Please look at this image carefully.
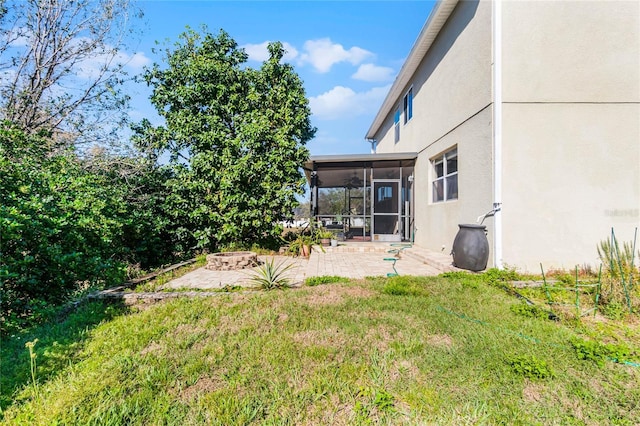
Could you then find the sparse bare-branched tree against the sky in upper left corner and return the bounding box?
[0,0,140,148]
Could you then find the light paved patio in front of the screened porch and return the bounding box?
[163,242,456,289]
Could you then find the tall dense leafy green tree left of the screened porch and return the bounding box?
[135,29,315,249]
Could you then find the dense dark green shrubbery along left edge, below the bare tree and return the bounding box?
[0,123,172,332]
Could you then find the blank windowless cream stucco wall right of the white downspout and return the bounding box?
[503,1,640,271]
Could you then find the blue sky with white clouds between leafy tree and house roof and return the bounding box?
[130,0,434,155]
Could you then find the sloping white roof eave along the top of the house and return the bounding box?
[365,0,458,140]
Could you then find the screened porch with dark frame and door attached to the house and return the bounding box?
[305,153,418,242]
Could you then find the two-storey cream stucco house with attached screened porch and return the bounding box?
[308,0,640,271]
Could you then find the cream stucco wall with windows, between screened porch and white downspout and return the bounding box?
[376,1,493,260]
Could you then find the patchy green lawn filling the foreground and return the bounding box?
[0,275,640,425]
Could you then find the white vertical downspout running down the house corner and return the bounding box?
[493,0,503,269]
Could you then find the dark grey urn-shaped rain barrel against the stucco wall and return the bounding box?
[451,224,489,271]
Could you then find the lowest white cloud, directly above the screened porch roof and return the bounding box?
[309,85,391,120]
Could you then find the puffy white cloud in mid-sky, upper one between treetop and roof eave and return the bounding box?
[300,38,373,73]
